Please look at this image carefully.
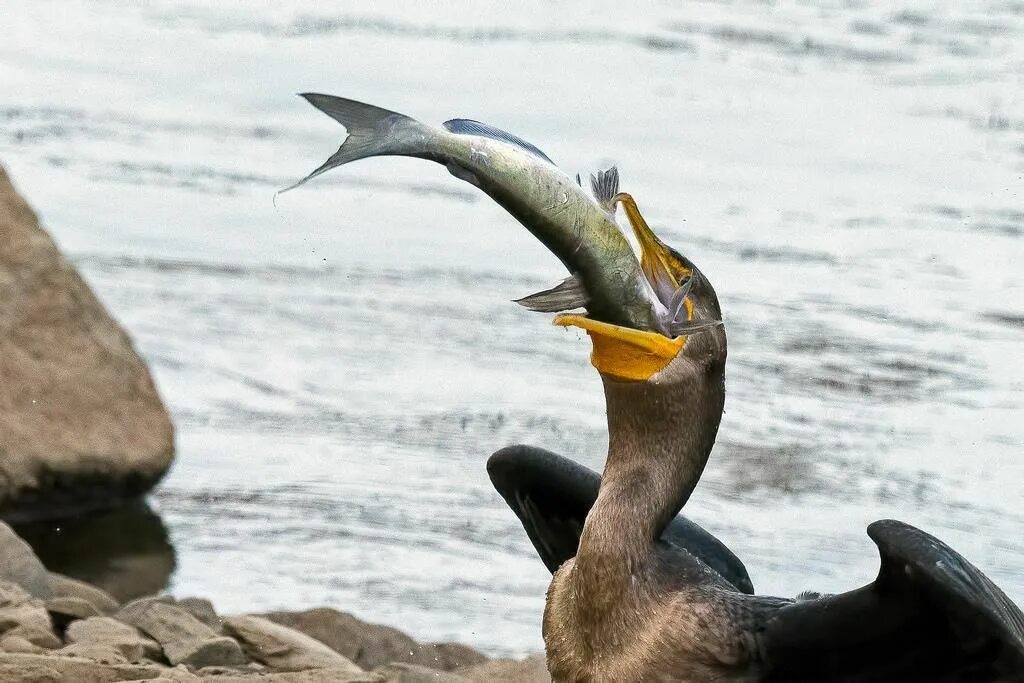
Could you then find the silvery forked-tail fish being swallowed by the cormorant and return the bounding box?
[282,92,720,338]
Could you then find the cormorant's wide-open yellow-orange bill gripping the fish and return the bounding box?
[554,193,721,381]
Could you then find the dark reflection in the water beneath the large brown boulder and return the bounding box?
[14,501,176,602]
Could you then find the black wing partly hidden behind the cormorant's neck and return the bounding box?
[487,445,754,594]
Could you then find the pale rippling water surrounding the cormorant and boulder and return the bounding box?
[0,0,1024,653]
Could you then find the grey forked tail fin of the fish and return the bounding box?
[281,92,432,193]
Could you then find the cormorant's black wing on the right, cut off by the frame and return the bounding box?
[750,520,1024,681]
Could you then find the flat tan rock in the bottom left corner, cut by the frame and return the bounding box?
[0,652,186,683]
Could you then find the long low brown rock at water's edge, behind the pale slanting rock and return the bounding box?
[263,607,486,671]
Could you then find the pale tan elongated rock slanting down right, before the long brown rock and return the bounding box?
[224,616,364,674]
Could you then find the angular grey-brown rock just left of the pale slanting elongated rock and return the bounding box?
[117,598,247,669]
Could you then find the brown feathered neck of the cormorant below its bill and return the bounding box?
[574,353,725,609]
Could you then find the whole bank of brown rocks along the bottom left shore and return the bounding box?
[0,522,549,683]
